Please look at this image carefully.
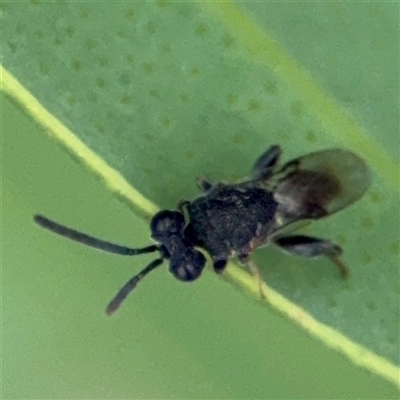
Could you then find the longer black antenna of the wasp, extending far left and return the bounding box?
[34,215,159,256]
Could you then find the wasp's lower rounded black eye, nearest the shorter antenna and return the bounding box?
[169,250,206,282]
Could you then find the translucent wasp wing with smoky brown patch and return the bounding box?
[274,149,371,224]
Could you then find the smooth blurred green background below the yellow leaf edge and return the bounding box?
[2,93,398,399]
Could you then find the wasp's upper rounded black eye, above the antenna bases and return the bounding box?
[150,210,185,241]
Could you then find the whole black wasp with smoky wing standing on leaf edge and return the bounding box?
[35,146,371,315]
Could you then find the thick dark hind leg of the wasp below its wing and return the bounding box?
[274,235,349,278]
